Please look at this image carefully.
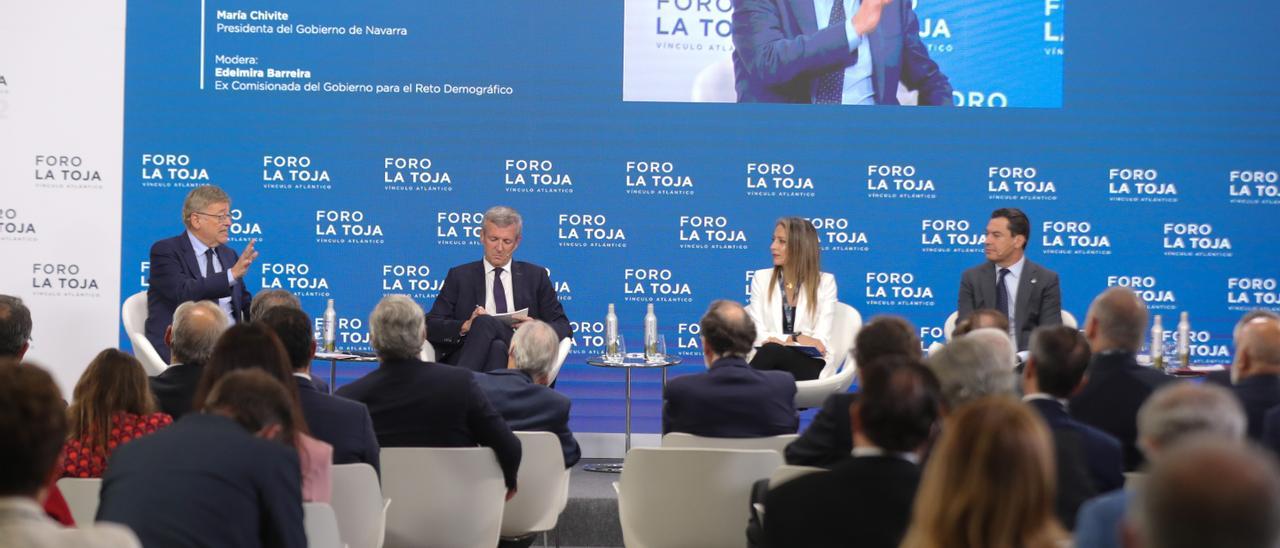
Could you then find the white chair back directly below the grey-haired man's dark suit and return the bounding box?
[381,447,507,548]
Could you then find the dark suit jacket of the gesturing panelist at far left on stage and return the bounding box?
[146,232,252,361]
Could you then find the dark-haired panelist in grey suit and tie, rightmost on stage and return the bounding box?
[956,207,1062,351]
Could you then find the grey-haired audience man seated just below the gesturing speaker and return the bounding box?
[147,301,227,420]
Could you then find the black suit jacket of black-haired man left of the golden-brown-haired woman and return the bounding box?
[764,456,920,548]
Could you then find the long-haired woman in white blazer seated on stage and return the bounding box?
[746,216,836,380]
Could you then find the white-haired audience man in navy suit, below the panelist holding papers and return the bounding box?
[475,320,582,467]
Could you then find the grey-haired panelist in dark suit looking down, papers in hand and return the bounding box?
[426,206,572,371]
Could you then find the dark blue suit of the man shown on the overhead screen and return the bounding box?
[733,0,952,106]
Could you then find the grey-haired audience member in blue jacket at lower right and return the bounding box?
[1075,383,1245,548]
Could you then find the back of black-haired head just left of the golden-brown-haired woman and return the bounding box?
[855,356,942,452]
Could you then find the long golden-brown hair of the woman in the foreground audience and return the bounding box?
[902,397,1070,548]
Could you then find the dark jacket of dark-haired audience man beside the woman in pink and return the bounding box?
[293,376,380,471]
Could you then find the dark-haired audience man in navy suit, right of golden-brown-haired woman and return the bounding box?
[1023,325,1124,529]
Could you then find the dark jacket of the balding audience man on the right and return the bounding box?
[1070,352,1171,470]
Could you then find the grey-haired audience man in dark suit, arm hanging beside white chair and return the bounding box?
[338,294,520,499]
